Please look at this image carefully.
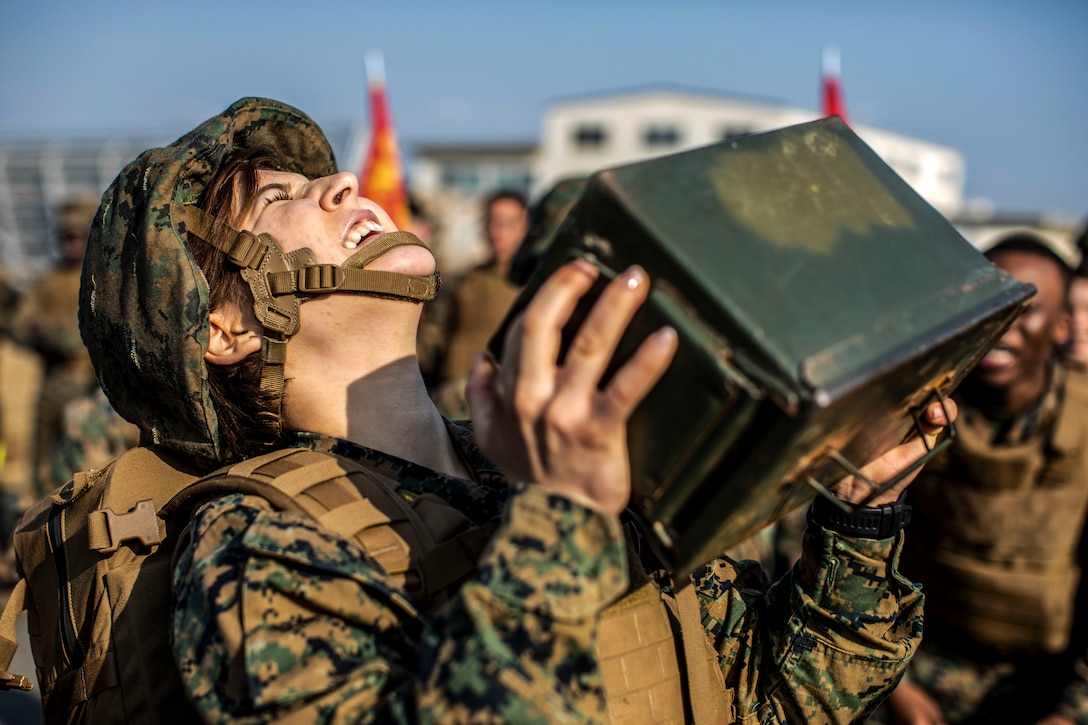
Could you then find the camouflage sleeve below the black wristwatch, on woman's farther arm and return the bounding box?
[693,522,923,724]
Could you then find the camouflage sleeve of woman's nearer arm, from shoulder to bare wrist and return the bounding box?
[171,487,627,723]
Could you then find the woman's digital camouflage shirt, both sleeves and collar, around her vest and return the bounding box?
[173,420,922,724]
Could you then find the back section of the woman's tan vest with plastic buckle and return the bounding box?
[0,447,199,723]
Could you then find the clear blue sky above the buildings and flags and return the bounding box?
[0,0,1088,220]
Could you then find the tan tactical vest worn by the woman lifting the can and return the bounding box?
[0,447,731,724]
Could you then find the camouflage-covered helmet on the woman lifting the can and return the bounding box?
[79,98,336,464]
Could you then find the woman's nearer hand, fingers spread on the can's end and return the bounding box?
[466,260,677,515]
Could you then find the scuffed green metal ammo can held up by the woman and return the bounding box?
[490,118,1035,575]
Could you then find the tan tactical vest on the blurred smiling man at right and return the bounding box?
[903,369,1088,653]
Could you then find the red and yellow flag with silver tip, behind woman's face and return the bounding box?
[359,51,411,230]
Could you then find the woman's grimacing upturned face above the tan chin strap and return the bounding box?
[236,171,435,277]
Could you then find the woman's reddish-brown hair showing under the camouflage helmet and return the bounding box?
[189,148,282,462]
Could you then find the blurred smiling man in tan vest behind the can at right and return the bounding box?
[888,233,1088,725]
